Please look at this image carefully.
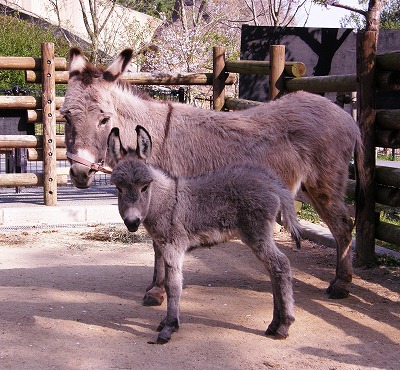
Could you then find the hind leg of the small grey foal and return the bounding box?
[246,227,294,339]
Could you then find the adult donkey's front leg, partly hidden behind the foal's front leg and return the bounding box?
[142,241,165,306]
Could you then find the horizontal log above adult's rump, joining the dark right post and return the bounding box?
[285,75,357,93]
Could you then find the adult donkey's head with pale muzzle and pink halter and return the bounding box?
[60,48,132,188]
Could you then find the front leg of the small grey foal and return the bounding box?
[157,246,184,344]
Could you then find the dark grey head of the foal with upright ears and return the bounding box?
[107,126,154,231]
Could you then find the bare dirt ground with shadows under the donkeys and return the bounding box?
[0,226,400,370]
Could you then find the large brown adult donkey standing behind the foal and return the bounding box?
[61,48,363,305]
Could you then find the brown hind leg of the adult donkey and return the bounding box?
[307,187,353,299]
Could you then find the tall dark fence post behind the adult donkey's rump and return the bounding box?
[355,31,378,266]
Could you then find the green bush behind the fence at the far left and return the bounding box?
[0,13,69,88]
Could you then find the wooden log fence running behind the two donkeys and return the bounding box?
[0,43,400,258]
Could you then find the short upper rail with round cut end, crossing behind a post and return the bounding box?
[225,60,306,77]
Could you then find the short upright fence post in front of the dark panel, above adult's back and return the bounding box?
[268,45,285,100]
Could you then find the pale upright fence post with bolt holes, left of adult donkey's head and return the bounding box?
[42,43,57,206]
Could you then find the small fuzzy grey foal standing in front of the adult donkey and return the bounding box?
[108,126,300,344]
